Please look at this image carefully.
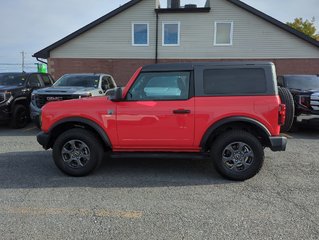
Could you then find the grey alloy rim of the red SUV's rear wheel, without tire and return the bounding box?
[222,142,254,172]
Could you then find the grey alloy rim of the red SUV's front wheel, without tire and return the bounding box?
[61,140,90,168]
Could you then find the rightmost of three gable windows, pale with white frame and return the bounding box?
[214,22,233,46]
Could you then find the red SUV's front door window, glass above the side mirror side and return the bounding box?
[127,72,190,101]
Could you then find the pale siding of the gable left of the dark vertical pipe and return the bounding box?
[50,0,156,59]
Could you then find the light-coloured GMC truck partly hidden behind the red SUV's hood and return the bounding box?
[30,73,116,125]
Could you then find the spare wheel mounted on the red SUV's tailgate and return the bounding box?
[278,87,295,132]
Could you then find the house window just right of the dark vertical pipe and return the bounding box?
[162,22,180,46]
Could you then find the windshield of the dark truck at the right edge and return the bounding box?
[285,75,319,90]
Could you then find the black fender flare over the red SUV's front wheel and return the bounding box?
[49,117,112,148]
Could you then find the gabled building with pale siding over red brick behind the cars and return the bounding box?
[34,0,319,85]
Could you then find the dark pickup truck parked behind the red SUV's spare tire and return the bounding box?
[278,75,319,127]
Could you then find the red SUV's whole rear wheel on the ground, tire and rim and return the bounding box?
[211,130,264,181]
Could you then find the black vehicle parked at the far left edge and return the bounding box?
[0,72,53,128]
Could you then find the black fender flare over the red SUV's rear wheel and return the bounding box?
[200,116,271,148]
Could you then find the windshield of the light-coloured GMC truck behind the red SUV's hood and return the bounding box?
[53,75,99,88]
